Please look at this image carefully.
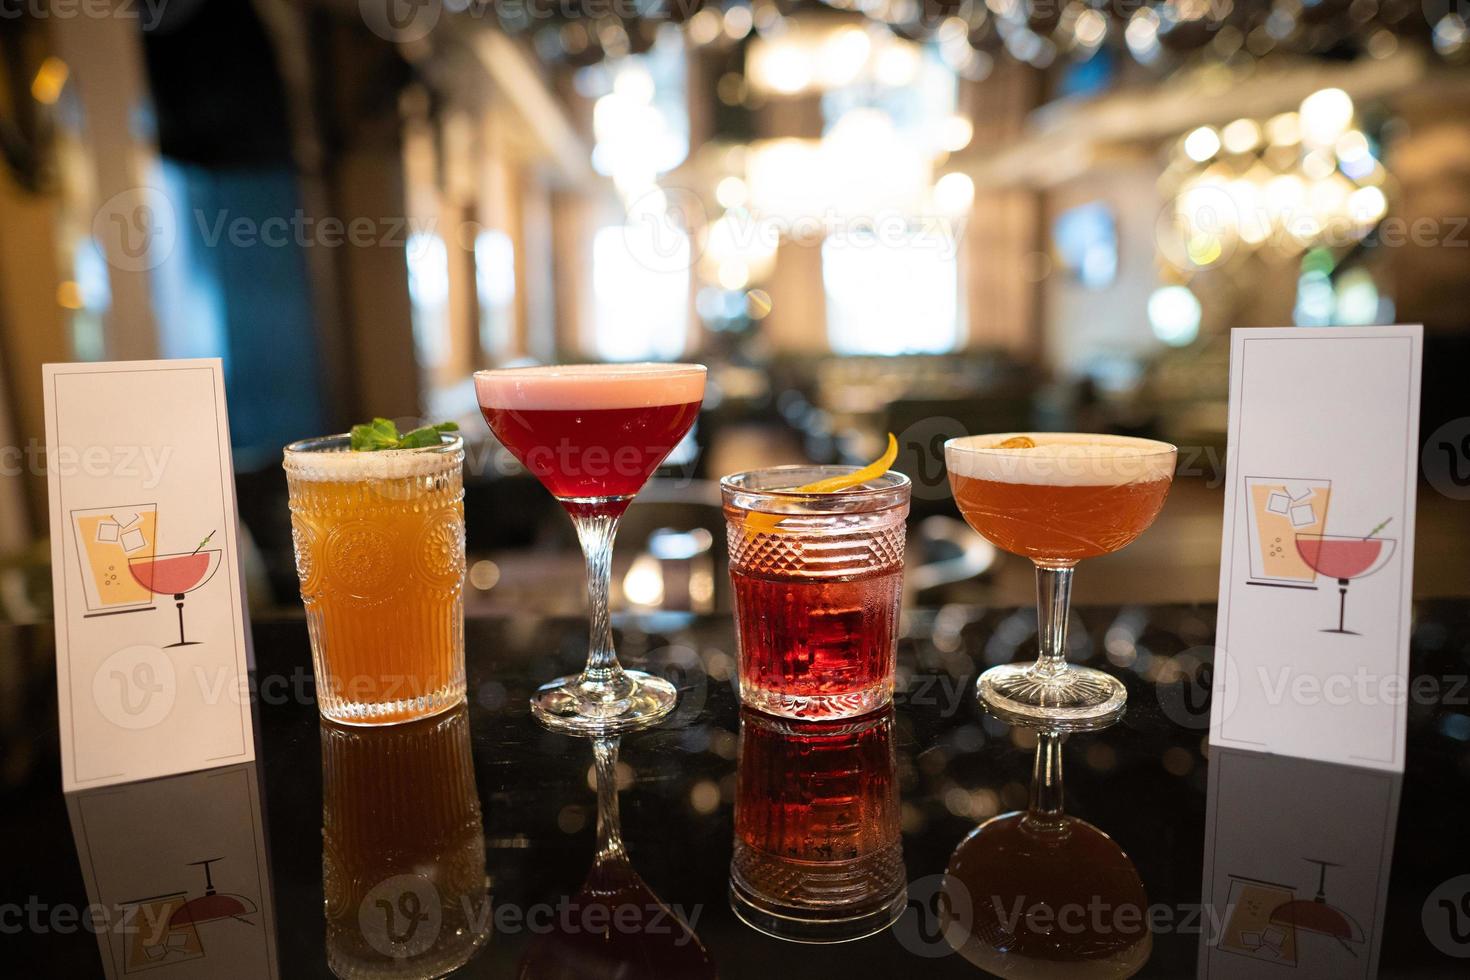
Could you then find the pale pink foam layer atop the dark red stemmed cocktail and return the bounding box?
[475,364,704,411]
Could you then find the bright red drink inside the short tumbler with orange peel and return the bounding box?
[731,564,904,717]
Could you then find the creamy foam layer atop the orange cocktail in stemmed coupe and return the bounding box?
[944,432,1177,486]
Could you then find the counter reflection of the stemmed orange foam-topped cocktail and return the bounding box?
[939,714,1154,980]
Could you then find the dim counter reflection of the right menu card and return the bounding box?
[1200,748,1401,980]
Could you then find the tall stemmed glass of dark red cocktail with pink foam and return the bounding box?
[475,364,704,733]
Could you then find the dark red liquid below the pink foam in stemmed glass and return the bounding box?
[481,401,700,497]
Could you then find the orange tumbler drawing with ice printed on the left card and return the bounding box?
[71,504,159,617]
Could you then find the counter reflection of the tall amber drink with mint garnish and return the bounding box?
[320,705,491,977]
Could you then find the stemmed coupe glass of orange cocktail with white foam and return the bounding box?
[944,432,1177,724]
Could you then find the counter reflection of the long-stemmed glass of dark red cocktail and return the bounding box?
[516,738,714,980]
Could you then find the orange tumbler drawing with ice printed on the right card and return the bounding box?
[1245,476,1332,589]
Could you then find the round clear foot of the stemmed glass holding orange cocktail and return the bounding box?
[976,664,1127,732]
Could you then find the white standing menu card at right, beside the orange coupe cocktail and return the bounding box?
[1210,326,1423,770]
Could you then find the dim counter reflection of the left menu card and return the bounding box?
[66,763,279,980]
